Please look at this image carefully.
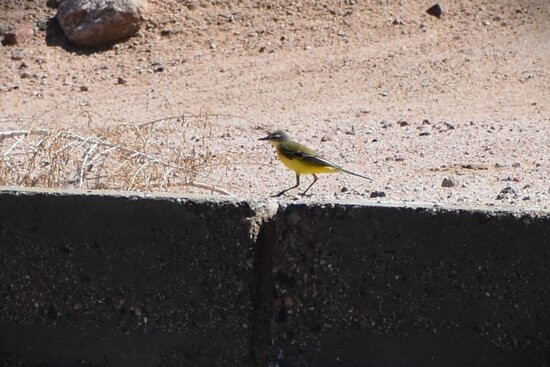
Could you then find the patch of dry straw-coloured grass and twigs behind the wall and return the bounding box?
[0,114,230,195]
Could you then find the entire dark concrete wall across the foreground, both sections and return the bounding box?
[0,191,550,366]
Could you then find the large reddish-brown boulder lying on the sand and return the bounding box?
[56,0,147,47]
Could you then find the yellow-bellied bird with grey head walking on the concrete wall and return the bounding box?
[260,130,372,196]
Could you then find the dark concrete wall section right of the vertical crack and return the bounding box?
[271,204,550,366]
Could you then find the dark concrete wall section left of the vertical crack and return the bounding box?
[0,192,260,366]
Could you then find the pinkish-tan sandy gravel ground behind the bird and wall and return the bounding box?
[0,0,550,210]
